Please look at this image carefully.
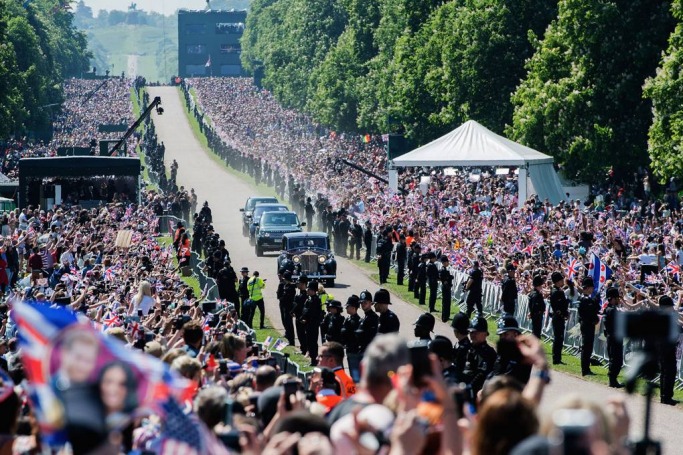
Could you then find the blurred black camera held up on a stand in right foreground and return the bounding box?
[615,310,680,344]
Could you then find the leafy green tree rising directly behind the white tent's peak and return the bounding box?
[382,0,555,143]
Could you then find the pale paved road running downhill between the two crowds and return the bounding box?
[149,87,683,453]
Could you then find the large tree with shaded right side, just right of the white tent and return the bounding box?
[507,0,673,181]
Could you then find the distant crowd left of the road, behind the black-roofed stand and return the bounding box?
[1,77,138,180]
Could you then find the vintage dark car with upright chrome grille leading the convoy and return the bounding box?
[277,232,337,288]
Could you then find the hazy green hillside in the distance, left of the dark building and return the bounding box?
[86,21,178,82]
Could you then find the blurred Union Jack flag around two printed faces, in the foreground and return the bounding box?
[12,301,196,447]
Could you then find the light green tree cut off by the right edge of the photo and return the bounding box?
[645,0,683,179]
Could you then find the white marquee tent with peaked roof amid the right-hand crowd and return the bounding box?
[389,120,564,205]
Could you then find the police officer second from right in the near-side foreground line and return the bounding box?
[463,316,496,397]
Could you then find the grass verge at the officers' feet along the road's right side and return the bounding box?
[349,259,683,407]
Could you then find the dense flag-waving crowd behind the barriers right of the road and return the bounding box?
[187,78,683,304]
